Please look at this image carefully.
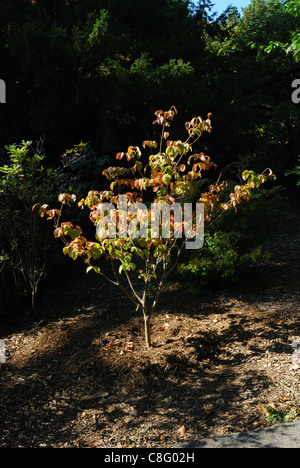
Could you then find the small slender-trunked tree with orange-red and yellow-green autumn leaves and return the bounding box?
[35,107,274,348]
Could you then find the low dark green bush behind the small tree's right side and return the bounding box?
[177,186,290,293]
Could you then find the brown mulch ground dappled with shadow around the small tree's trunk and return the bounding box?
[0,210,300,448]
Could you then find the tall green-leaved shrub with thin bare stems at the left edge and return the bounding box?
[0,141,59,313]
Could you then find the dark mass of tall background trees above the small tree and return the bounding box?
[0,0,300,318]
